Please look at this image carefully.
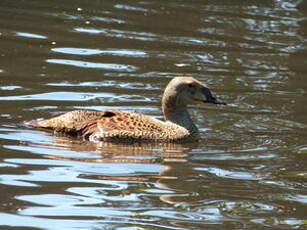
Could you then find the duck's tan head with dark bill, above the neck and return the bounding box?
[162,77,226,107]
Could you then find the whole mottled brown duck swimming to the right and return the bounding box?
[26,76,226,142]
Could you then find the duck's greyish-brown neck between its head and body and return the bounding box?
[162,101,198,133]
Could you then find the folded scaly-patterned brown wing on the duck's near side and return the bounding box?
[90,111,190,142]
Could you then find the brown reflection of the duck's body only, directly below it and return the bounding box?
[45,136,190,163]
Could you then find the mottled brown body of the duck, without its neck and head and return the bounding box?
[30,110,190,142]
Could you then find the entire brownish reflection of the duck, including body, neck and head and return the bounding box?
[38,137,197,204]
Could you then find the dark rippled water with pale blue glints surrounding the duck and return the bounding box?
[0,0,307,230]
